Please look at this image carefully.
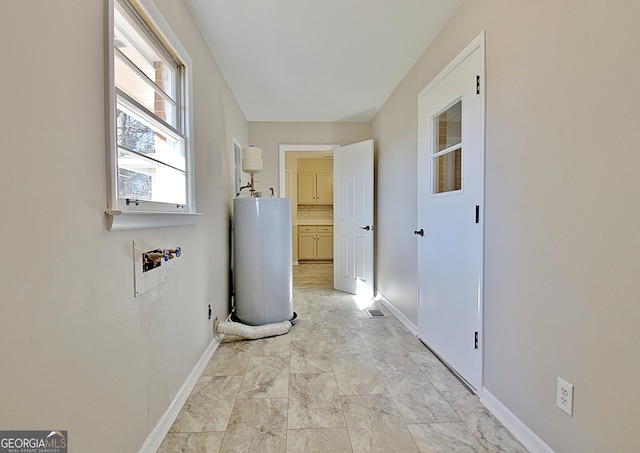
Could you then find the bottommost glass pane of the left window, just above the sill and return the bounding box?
[118,148,187,205]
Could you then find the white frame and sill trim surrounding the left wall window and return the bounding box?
[105,0,199,231]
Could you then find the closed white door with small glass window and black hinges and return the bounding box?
[416,36,484,390]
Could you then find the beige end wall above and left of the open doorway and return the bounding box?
[249,122,371,193]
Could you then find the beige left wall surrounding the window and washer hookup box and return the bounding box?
[0,0,248,452]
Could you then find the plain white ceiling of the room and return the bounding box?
[185,0,462,122]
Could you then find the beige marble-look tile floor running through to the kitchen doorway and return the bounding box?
[158,263,527,453]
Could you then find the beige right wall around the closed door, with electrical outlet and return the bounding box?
[371,0,640,453]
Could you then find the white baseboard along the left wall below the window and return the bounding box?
[139,337,220,453]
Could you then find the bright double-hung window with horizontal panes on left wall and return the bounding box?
[107,0,195,229]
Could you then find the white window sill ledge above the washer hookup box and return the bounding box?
[105,210,202,231]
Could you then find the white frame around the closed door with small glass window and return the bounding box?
[418,31,486,395]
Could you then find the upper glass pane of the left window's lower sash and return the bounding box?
[116,105,186,171]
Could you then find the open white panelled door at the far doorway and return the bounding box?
[333,140,374,297]
